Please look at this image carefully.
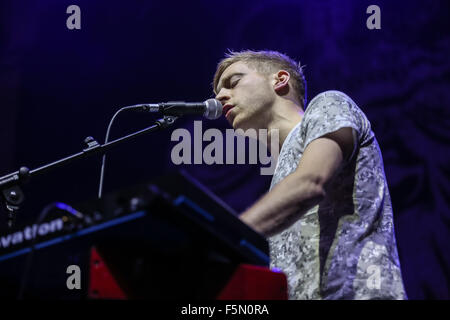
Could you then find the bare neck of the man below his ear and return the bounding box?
[267,100,304,151]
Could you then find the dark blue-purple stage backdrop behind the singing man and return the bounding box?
[0,0,450,299]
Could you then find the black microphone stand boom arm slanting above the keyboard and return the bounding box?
[0,116,177,228]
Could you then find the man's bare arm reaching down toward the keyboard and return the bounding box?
[240,128,356,236]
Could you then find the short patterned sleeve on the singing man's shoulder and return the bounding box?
[302,91,368,158]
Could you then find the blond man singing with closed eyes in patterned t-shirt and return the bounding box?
[214,51,406,299]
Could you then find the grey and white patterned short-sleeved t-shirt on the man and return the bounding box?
[268,91,406,299]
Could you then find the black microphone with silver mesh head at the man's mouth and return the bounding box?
[133,99,223,120]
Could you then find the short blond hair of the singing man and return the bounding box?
[213,50,306,109]
